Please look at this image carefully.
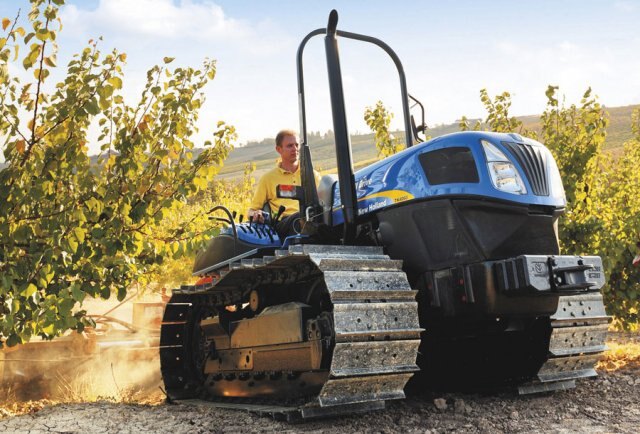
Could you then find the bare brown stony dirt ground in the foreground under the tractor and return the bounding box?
[0,334,640,434]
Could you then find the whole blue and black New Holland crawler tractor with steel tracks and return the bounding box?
[160,11,609,420]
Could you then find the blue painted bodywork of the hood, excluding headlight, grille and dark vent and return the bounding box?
[332,131,566,225]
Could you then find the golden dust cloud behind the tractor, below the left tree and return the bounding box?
[0,296,164,408]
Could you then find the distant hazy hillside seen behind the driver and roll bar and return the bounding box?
[218,105,640,179]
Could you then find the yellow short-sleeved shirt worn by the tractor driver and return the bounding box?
[249,162,320,216]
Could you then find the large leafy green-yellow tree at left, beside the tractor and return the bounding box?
[0,0,235,345]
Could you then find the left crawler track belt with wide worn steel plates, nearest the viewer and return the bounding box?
[160,245,422,420]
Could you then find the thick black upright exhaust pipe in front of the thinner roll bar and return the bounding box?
[324,9,357,244]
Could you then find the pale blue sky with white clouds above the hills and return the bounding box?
[0,0,640,151]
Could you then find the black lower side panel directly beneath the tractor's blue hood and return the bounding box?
[377,199,561,273]
